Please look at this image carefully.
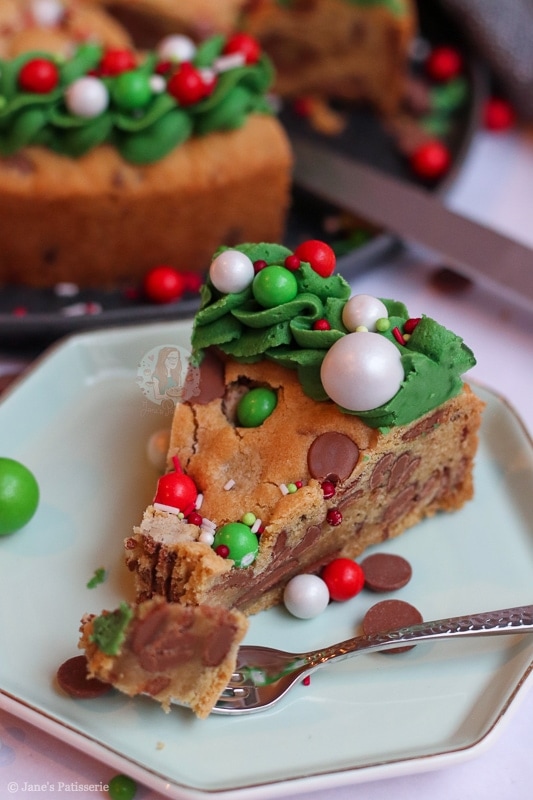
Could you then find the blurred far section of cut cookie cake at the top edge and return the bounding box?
[90,0,417,114]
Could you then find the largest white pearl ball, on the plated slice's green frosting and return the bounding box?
[320,332,405,411]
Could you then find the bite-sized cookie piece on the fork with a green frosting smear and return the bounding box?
[79,598,248,718]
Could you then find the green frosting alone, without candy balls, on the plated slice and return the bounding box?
[192,243,476,430]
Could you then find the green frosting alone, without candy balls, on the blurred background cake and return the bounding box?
[0,36,274,164]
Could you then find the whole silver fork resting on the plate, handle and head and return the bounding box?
[213,605,533,714]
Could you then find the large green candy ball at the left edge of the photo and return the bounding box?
[0,458,39,536]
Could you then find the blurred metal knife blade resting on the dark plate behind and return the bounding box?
[292,139,533,309]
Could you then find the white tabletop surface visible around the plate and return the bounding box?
[0,132,533,800]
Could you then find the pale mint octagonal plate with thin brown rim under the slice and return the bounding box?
[0,322,533,800]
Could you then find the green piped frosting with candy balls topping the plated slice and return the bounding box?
[192,242,476,430]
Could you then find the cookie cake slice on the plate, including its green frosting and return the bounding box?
[125,241,483,614]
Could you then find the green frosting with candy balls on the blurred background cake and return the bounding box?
[0,36,274,164]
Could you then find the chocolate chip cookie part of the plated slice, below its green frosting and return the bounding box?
[125,362,483,614]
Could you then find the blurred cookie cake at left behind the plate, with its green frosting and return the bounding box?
[0,16,291,288]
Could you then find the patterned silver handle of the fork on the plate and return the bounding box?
[305,605,533,668]
